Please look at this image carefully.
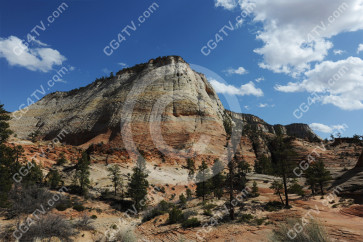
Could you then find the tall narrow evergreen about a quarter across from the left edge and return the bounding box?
[75,152,91,195]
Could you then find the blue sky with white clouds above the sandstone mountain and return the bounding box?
[0,0,363,137]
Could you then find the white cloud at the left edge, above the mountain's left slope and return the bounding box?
[0,36,66,72]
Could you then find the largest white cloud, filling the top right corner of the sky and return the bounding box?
[239,0,363,77]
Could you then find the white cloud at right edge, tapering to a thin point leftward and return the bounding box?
[275,57,363,110]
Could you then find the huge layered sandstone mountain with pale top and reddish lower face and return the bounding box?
[10,56,318,164]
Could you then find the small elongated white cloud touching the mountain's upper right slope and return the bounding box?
[210,79,263,97]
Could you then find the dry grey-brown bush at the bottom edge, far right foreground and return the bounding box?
[271,219,329,242]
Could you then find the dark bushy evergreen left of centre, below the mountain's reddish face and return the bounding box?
[128,156,149,210]
